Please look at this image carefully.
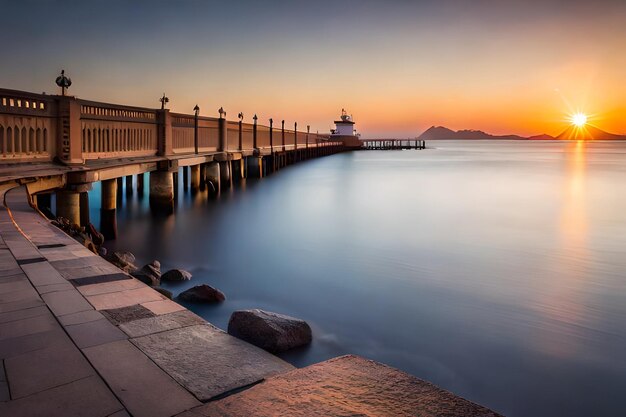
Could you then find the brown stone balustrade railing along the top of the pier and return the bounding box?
[0,89,329,165]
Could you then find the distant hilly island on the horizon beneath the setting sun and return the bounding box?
[418,125,626,140]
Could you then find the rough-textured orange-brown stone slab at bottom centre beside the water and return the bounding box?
[193,355,501,417]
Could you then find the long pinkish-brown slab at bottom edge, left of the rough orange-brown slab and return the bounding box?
[83,340,201,417]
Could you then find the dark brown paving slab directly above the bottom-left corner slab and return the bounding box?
[4,341,95,399]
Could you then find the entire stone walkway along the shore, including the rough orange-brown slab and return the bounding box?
[0,187,499,417]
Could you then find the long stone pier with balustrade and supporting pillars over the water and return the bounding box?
[0,89,350,239]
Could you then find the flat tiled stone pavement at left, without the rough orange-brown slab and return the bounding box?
[0,188,293,417]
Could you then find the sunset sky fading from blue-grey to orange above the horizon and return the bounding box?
[0,0,626,137]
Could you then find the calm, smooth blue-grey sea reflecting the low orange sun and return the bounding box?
[91,141,626,417]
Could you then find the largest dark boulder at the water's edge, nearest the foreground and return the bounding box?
[228,309,313,353]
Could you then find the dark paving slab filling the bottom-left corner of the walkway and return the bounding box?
[0,376,123,417]
